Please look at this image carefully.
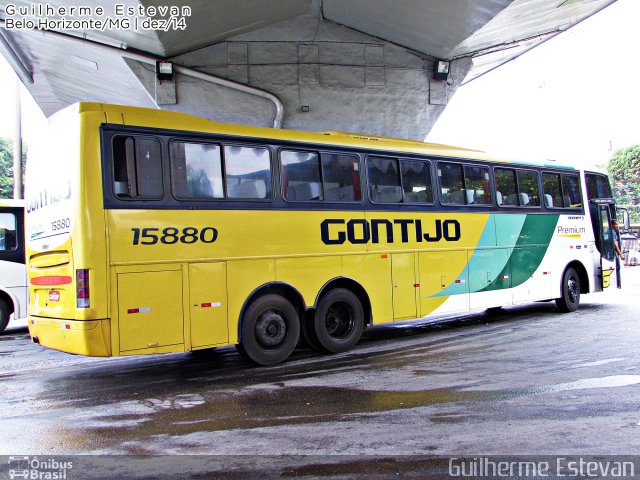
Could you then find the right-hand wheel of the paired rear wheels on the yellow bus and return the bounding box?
[314,288,364,353]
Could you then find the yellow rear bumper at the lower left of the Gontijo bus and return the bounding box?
[28,316,111,357]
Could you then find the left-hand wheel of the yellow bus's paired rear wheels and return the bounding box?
[238,295,300,365]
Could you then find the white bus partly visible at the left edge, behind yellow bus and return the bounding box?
[0,199,27,332]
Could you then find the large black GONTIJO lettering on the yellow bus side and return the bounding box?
[320,218,460,245]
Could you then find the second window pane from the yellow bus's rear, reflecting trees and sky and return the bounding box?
[170,142,224,199]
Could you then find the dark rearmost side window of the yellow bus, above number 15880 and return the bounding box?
[113,136,163,198]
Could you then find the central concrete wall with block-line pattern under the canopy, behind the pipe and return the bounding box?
[128,14,471,140]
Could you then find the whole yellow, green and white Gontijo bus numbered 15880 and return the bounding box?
[27,103,616,364]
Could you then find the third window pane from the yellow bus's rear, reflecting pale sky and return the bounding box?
[224,145,272,199]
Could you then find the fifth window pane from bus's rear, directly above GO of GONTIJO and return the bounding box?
[322,153,362,202]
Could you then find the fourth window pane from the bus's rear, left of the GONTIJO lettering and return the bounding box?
[280,150,324,201]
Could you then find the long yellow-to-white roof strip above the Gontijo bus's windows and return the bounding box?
[74,102,573,169]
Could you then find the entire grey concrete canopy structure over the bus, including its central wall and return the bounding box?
[0,0,615,139]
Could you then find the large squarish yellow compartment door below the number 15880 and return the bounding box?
[118,270,184,352]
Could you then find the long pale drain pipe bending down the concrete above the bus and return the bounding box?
[0,19,284,128]
